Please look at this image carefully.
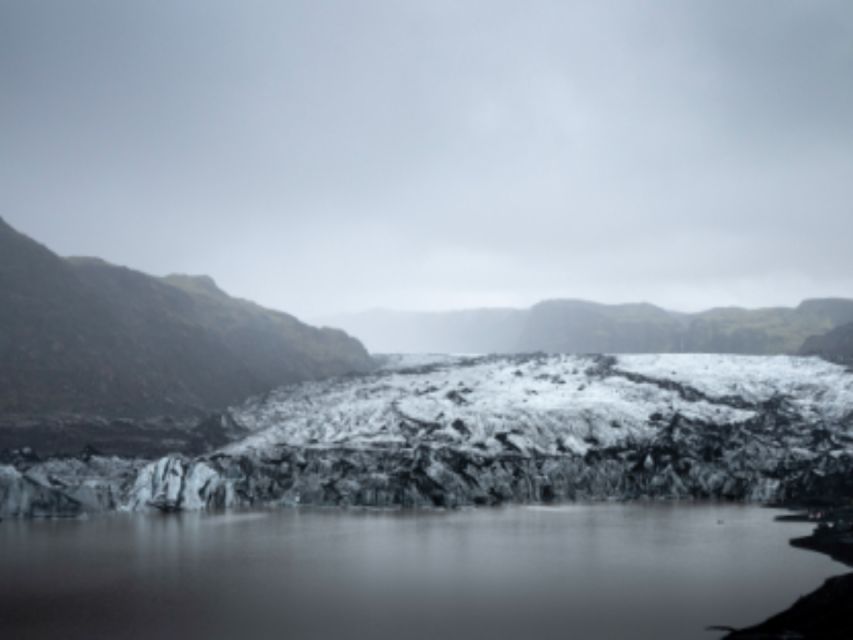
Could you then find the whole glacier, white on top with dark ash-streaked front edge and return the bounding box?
[0,354,853,517]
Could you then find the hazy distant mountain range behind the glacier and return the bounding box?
[323,298,853,356]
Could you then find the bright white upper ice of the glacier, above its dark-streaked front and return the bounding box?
[225,354,853,454]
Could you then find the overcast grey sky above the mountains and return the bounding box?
[0,0,853,317]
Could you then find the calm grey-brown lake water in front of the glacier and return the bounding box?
[0,503,845,640]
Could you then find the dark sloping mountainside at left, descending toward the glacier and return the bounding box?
[0,220,373,418]
